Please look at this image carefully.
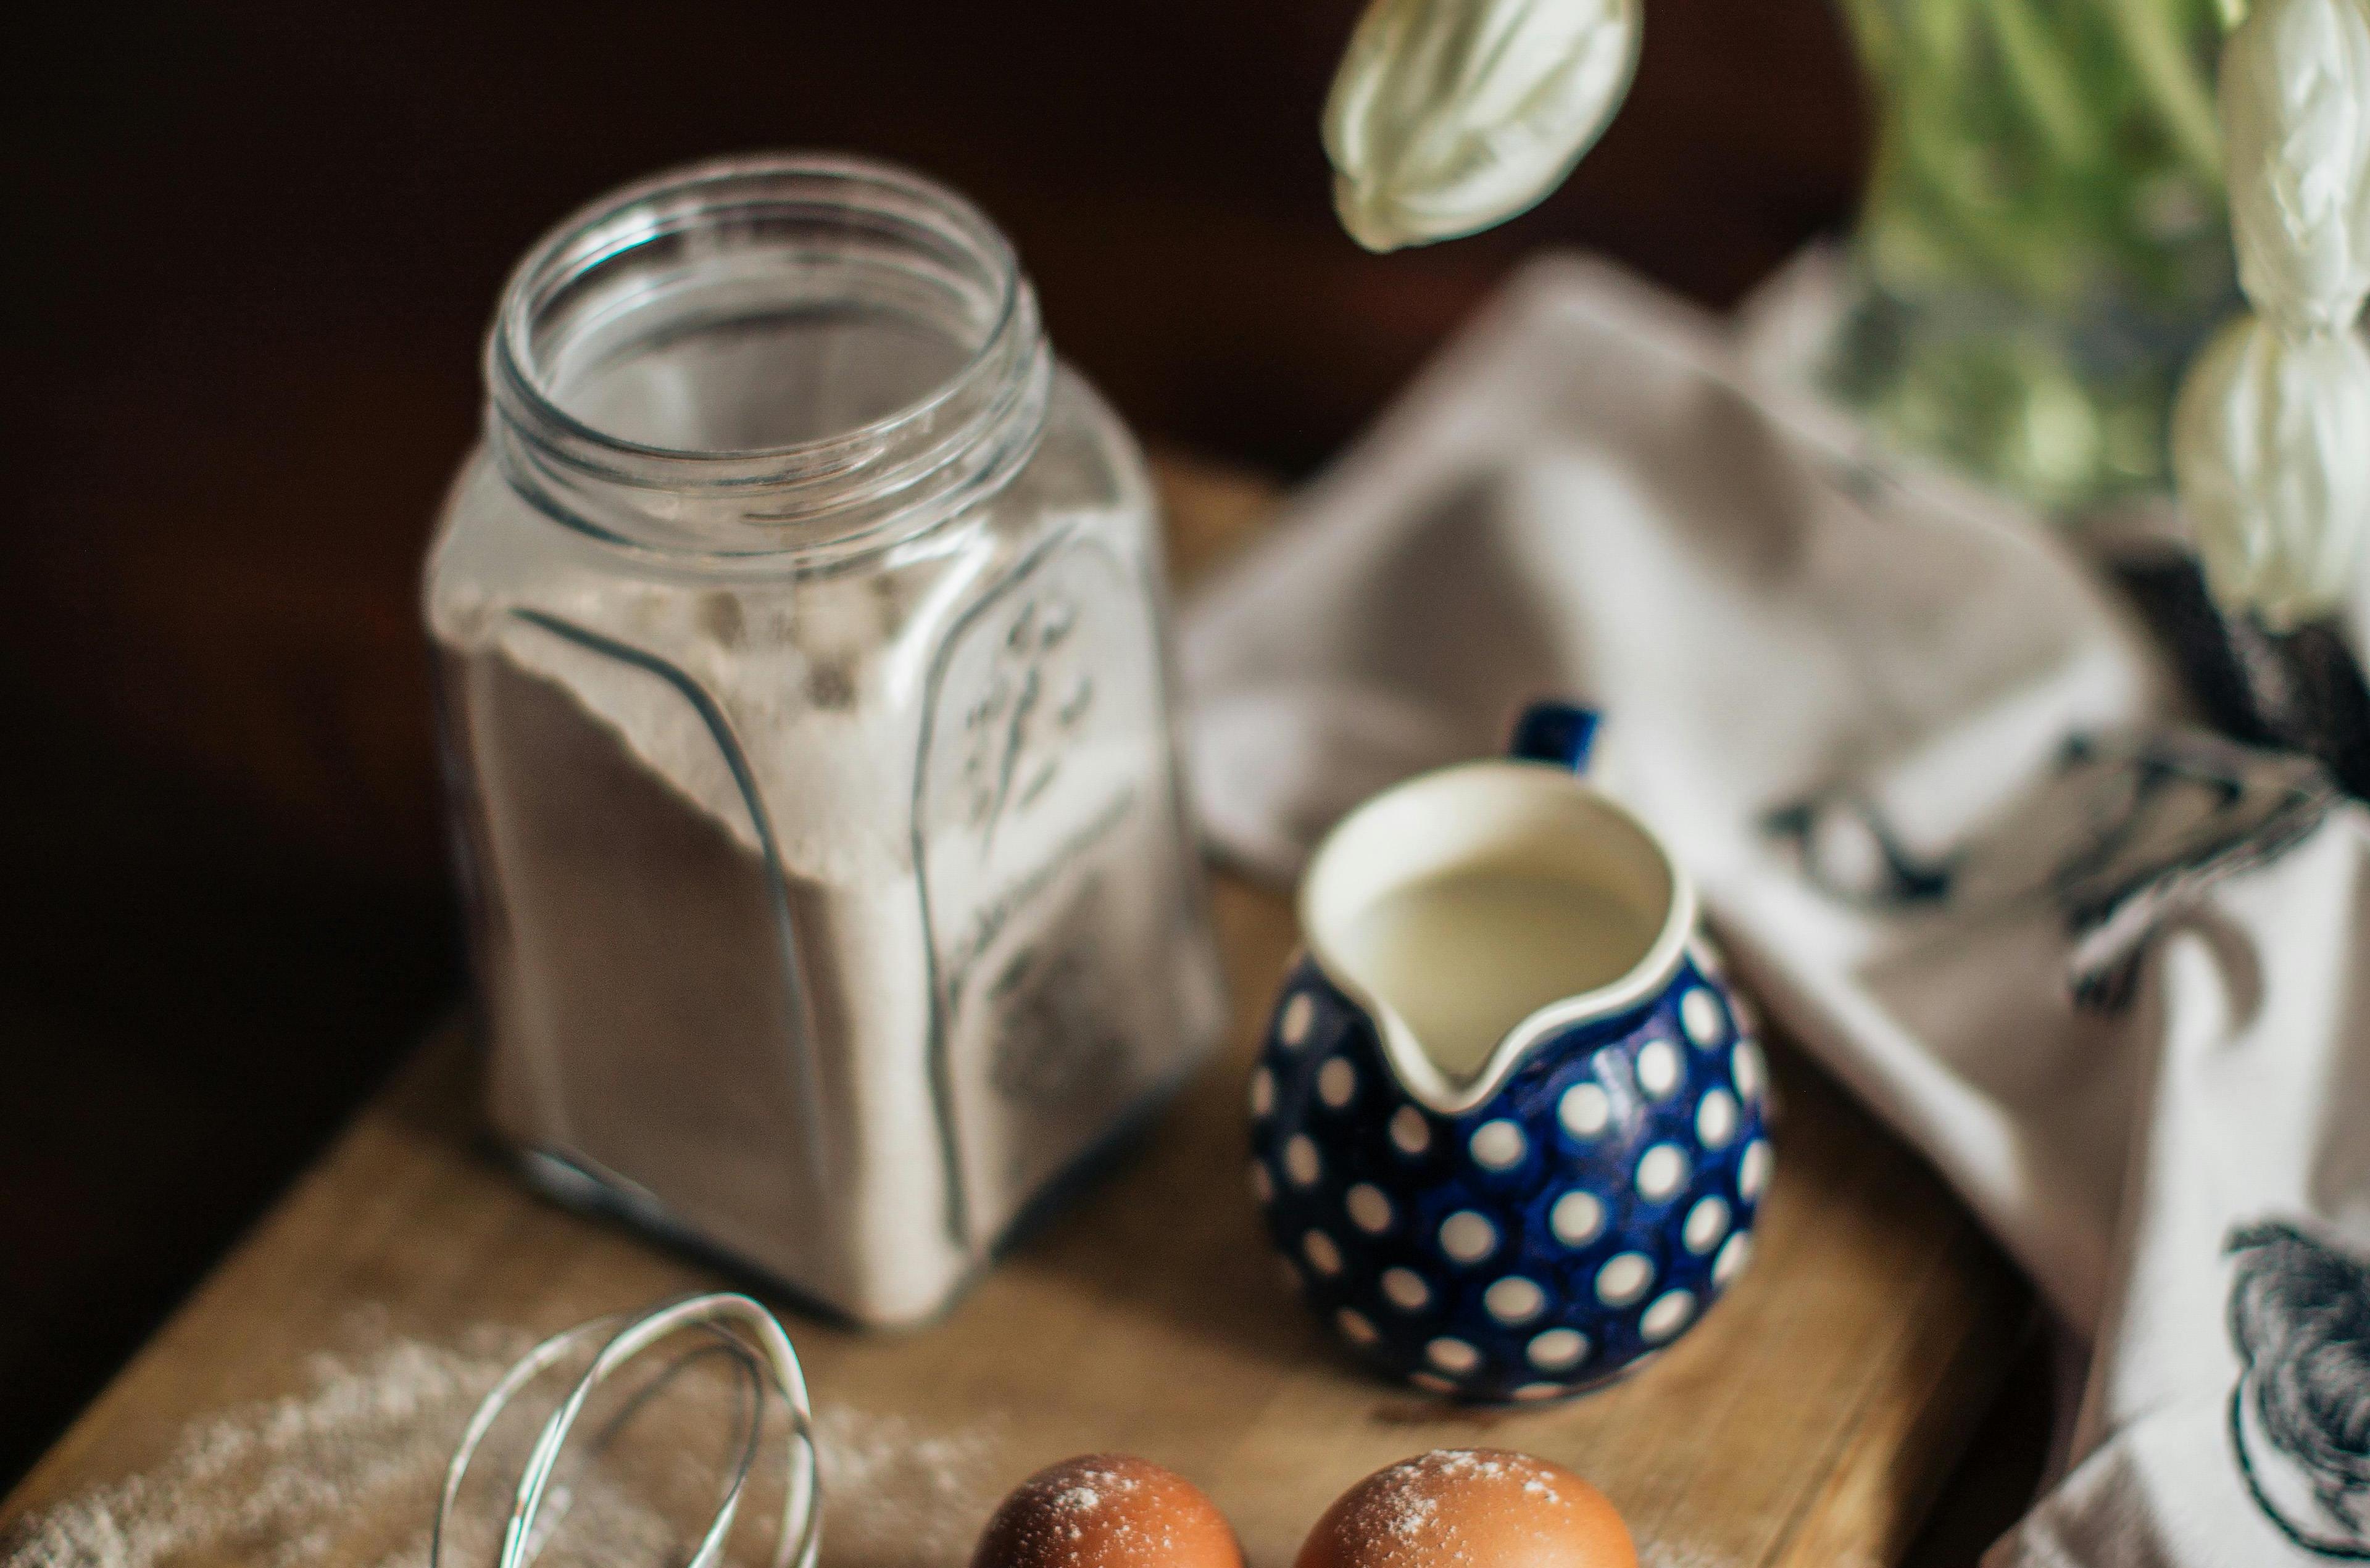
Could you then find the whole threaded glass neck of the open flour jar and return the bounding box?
[486,152,1052,559]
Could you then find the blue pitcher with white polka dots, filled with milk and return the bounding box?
[1252,703,1770,1400]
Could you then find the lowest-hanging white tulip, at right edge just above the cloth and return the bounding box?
[2173,315,2370,630]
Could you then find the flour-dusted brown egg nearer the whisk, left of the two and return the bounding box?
[971,1454,1242,1568]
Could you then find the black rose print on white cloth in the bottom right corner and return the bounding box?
[2223,1220,2370,1561]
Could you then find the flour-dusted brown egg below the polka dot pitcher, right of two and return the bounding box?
[1294,1447,1637,1568]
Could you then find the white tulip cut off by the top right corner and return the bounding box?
[2221,0,2370,327]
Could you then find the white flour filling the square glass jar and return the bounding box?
[431,469,1223,1322]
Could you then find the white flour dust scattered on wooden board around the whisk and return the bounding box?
[0,1326,996,1568]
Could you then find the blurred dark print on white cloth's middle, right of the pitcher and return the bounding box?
[1763,732,2337,1009]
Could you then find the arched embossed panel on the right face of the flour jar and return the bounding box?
[915,535,1192,1246]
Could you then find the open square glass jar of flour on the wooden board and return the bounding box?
[426,156,1223,1322]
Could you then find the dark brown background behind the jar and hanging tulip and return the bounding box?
[0,0,1865,1487]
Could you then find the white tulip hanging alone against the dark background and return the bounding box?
[1325,0,1640,251]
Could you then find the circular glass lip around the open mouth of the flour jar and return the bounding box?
[486,152,1029,476]
